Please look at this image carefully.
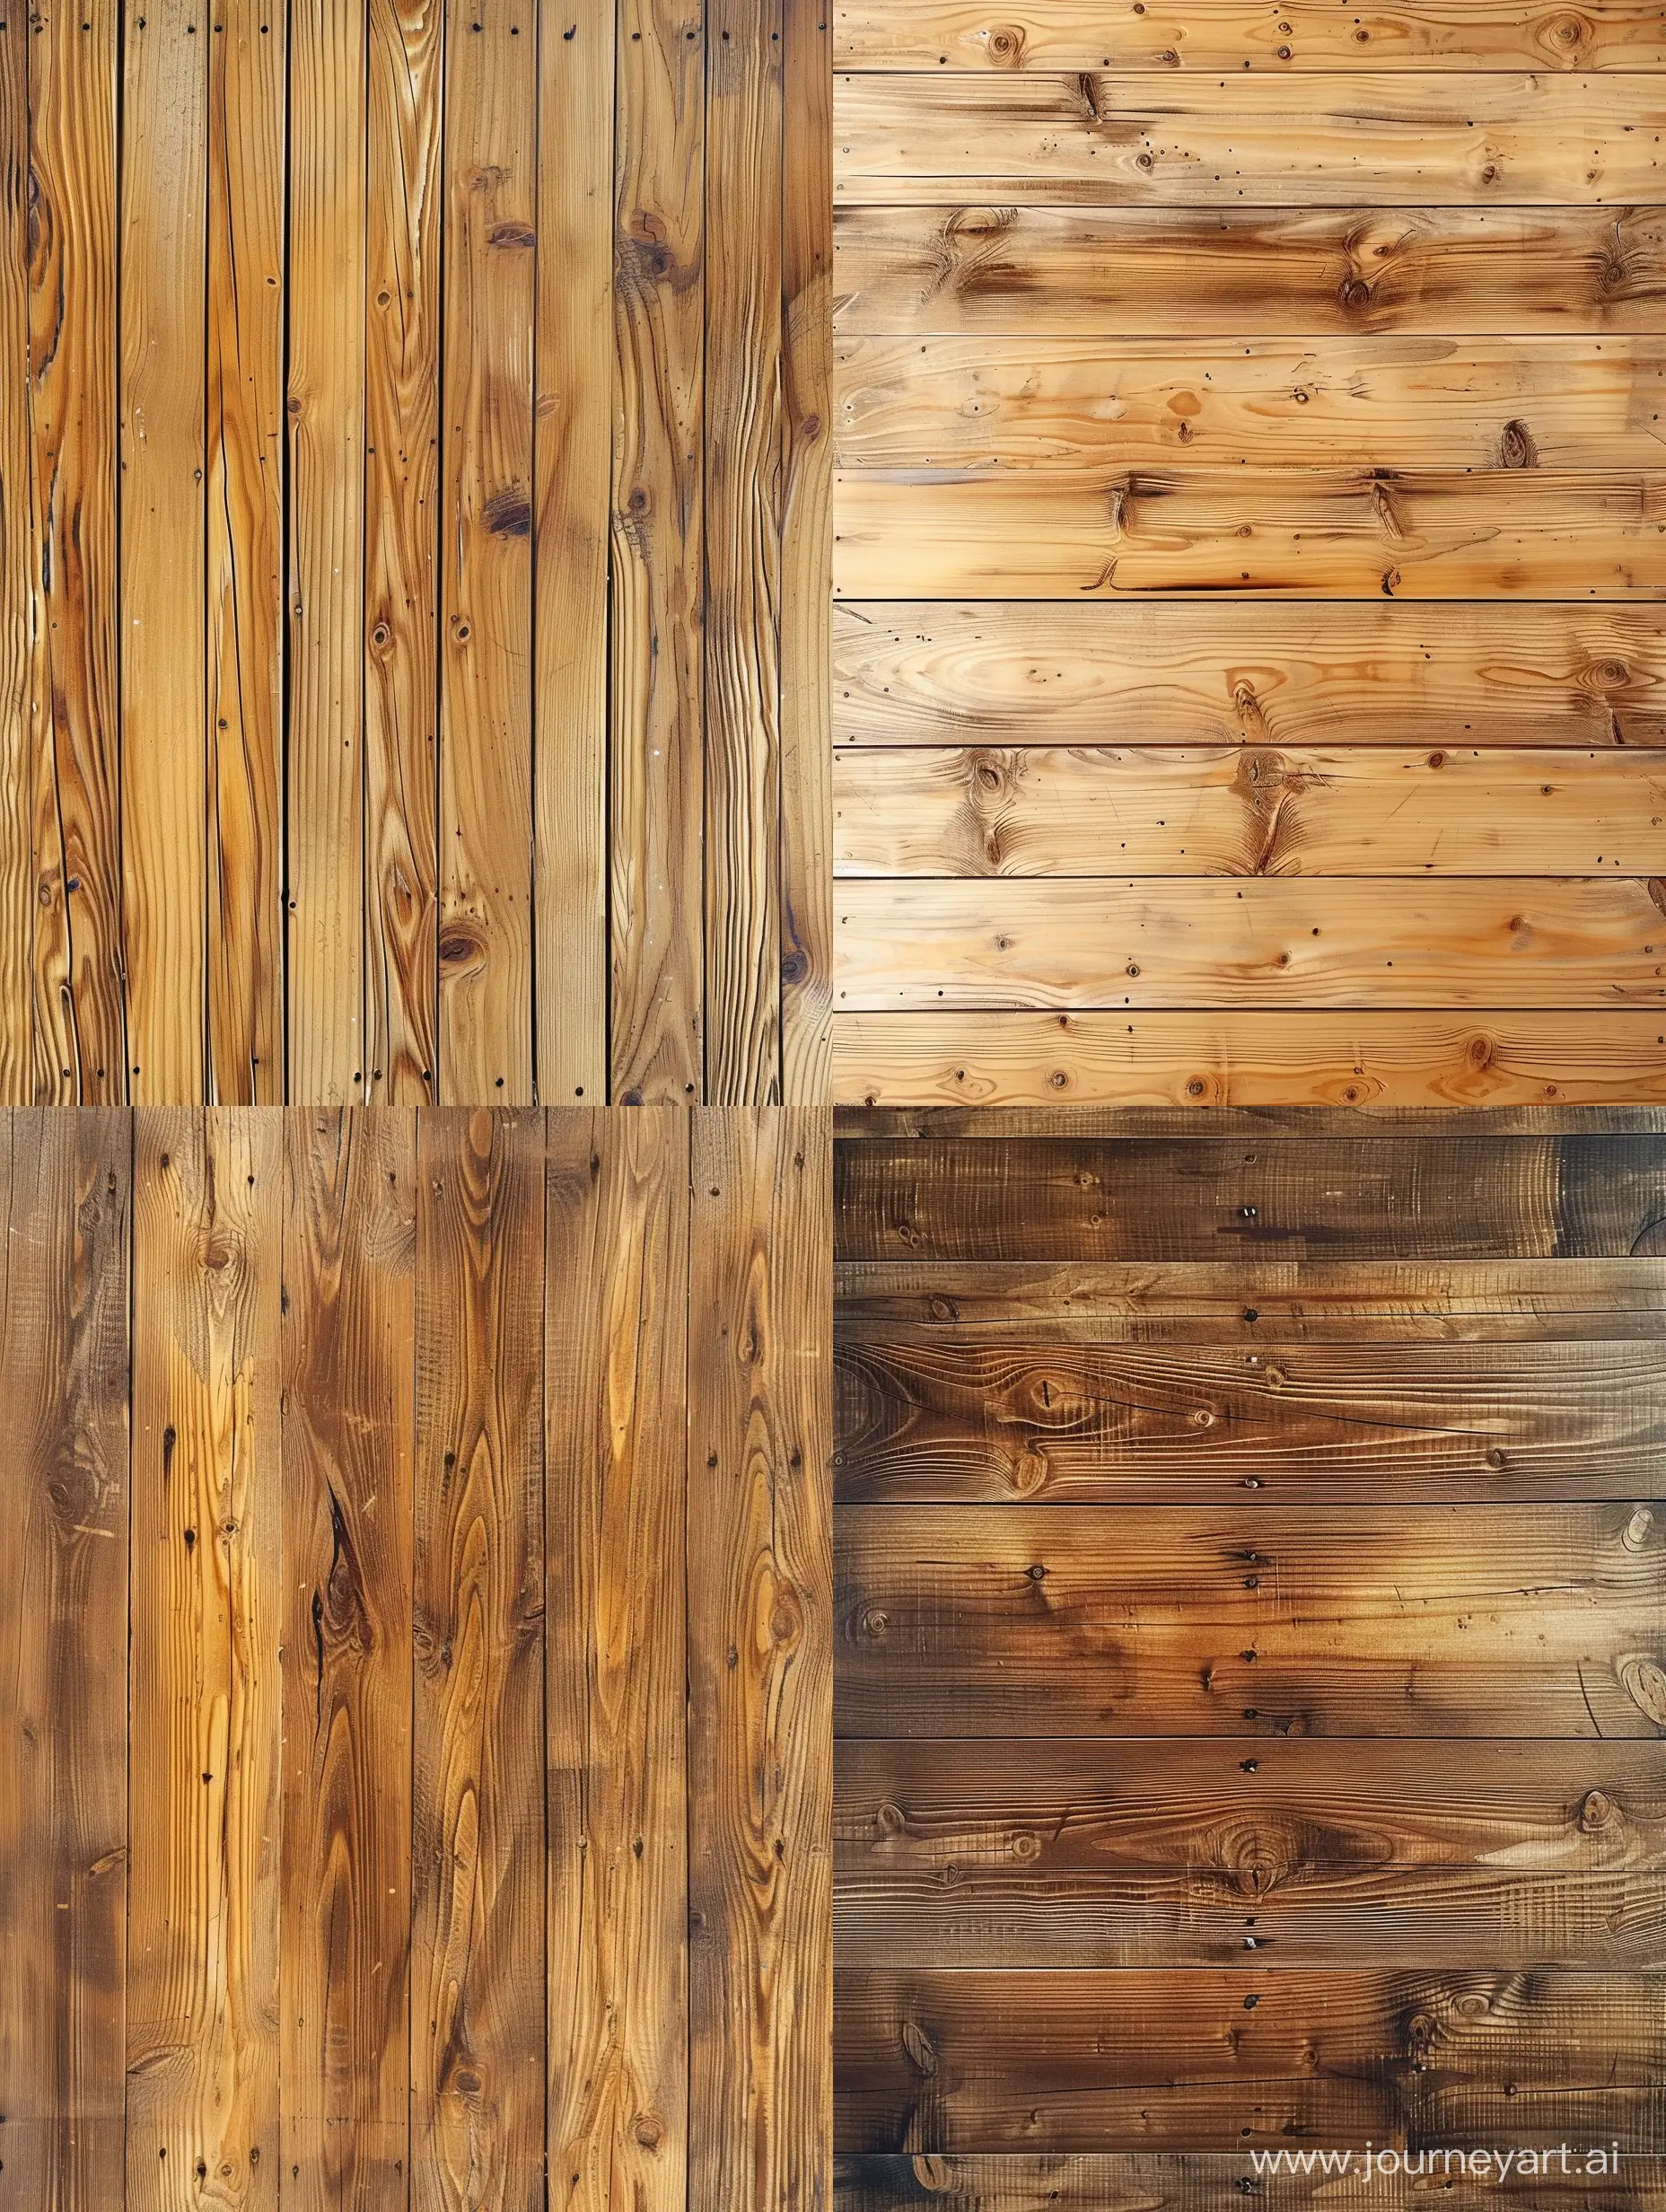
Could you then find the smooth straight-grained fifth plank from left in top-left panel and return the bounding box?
[287,0,367,1106]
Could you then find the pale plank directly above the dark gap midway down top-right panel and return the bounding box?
[834,467,1666,601]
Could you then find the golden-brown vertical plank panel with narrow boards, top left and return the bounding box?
[0,0,832,1106]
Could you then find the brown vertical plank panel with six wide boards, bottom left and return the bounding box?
[0,1106,832,2212]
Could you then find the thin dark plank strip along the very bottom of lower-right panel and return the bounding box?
[834,2158,1666,2212]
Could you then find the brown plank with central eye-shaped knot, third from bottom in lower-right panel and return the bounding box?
[834,1741,1666,1973]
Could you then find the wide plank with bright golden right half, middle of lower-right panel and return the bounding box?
[834,1505,1666,1739]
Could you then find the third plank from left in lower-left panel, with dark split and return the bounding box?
[281,1108,416,2212]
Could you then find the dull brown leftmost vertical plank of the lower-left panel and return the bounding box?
[0,1108,128,2212]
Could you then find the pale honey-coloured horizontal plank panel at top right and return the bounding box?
[832,0,1666,1106]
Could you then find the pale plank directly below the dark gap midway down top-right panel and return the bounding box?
[832,600,1666,750]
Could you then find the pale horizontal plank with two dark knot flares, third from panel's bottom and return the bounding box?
[834,745,1666,876]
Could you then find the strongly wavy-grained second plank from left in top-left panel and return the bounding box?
[29,0,128,1104]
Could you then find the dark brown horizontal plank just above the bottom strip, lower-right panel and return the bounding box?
[834,1969,1666,2141]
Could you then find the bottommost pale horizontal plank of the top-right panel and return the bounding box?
[834,1011,1666,1117]
